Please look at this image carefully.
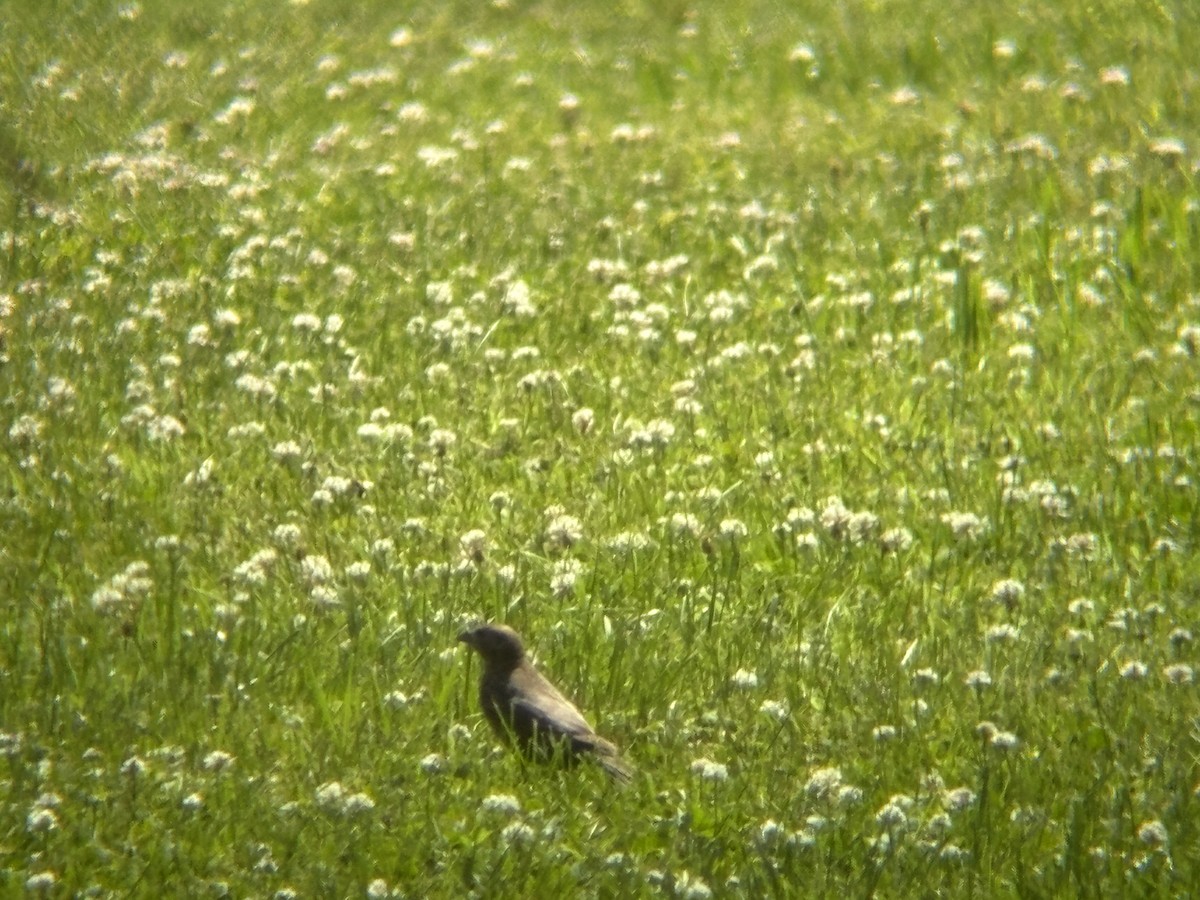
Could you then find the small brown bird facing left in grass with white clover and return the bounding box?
[458,624,632,782]
